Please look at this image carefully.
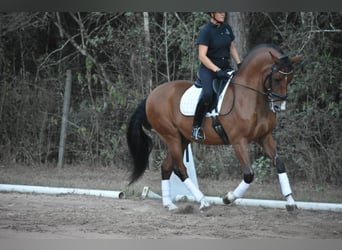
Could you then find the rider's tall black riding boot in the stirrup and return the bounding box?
[191,98,208,141]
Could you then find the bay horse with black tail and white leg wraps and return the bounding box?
[127,44,301,210]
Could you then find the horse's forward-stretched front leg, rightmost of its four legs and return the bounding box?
[262,134,297,211]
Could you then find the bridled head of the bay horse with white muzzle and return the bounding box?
[264,51,301,112]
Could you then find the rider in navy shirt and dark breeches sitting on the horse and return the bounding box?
[191,12,241,141]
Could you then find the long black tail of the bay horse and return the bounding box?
[127,99,152,184]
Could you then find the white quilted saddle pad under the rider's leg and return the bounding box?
[179,77,232,116]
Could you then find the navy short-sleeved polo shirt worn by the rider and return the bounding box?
[197,22,235,68]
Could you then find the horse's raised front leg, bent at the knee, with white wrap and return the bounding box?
[223,139,254,204]
